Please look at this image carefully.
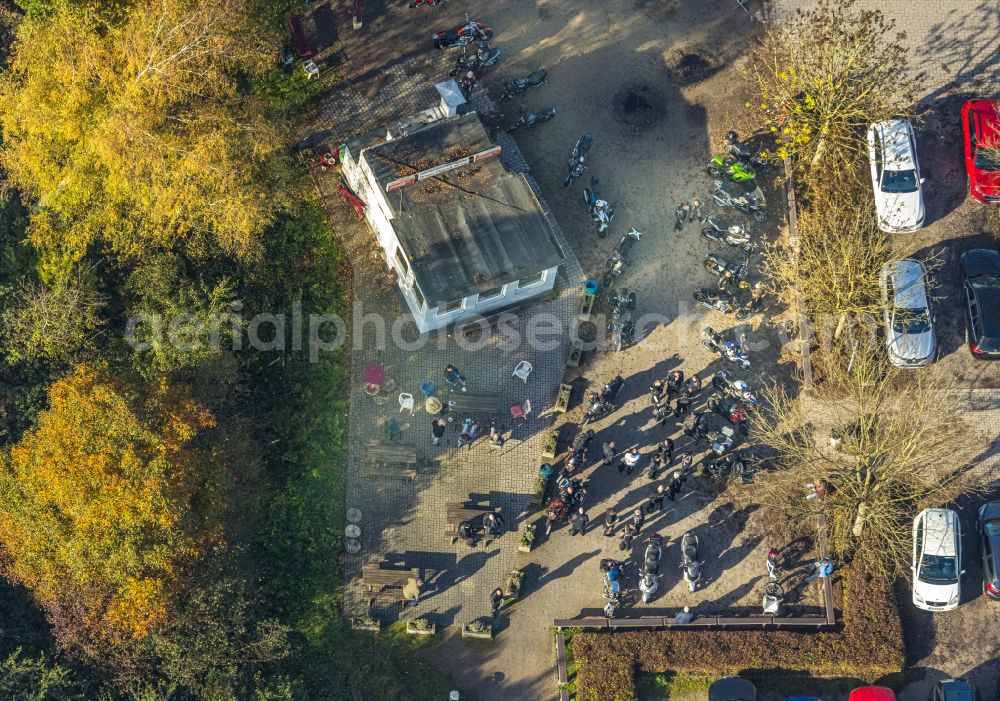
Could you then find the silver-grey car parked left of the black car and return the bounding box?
[880,259,938,368]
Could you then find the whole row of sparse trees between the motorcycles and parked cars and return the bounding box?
[748,0,977,577]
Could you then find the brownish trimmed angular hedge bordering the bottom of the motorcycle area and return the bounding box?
[573,567,903,701]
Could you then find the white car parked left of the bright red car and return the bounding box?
[868,119,924,233]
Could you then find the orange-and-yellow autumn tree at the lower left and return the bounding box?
[0,366,229,647]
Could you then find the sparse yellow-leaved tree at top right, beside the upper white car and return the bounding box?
[747,0,916,180]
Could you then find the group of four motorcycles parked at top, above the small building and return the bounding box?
[433,18,556,132]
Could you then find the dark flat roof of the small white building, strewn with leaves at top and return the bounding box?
[363,113,564,307]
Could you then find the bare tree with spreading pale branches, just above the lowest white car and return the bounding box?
[751,337,979,576]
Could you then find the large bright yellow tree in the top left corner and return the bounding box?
[0,0,283,269]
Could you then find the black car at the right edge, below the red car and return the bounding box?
[961,248,1000,360]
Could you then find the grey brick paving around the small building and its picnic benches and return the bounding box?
[306,85,583,625]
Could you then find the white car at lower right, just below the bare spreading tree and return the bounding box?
[913,509,964,611]
